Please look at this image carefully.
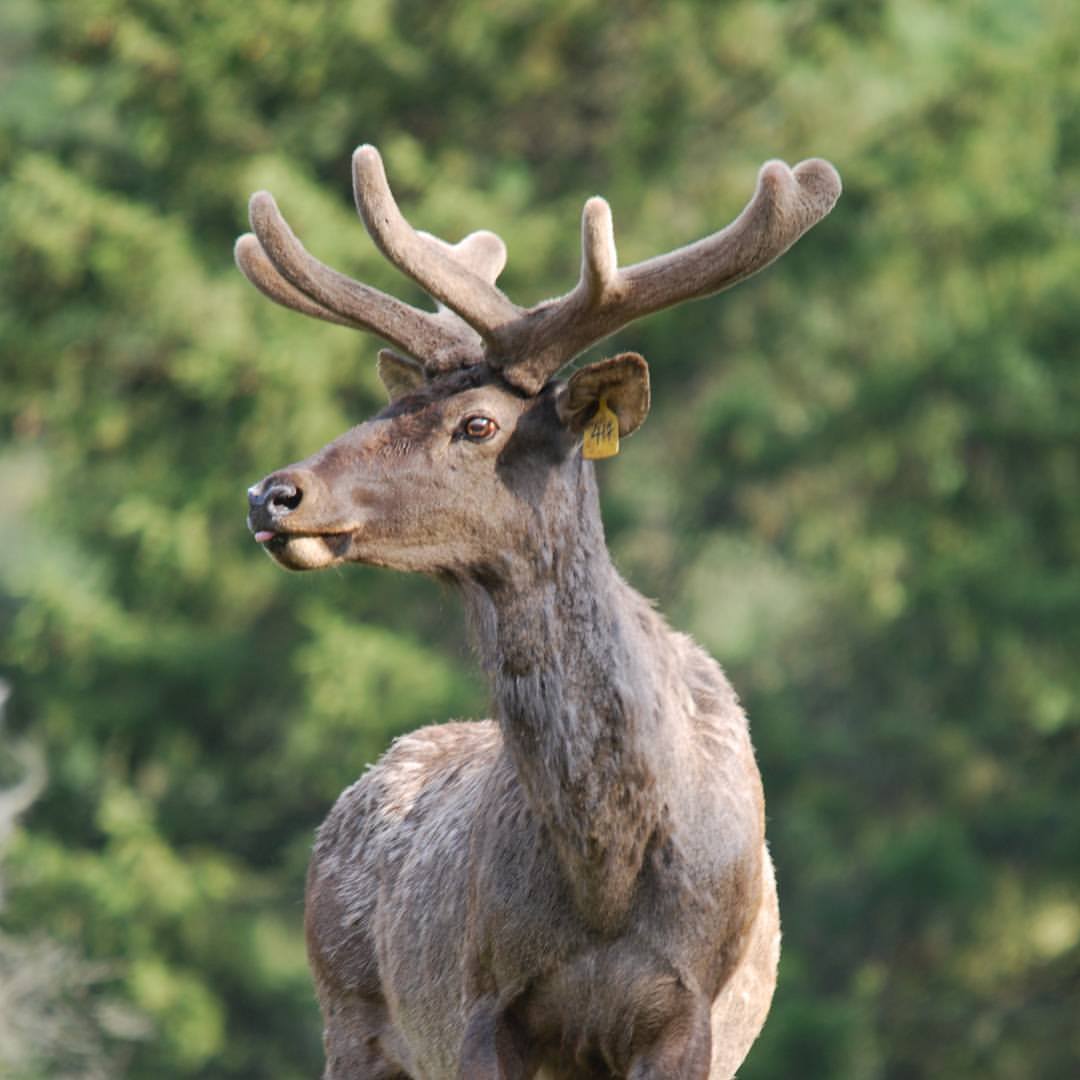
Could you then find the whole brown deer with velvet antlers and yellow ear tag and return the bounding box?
[235,146,840,1080]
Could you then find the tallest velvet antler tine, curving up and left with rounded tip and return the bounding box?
[352,146,522,338]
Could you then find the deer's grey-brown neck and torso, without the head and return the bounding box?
[308,432,778,1077]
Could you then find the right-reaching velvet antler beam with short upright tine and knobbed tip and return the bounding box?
[498,159,840,393]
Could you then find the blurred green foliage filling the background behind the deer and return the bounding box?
[0,0,1080,1080]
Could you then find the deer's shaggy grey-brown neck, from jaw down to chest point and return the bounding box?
[464,465,677,930]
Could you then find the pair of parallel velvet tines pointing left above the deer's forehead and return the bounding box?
[245,191,483,369]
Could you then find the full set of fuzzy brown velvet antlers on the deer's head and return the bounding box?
[237,146,840,393]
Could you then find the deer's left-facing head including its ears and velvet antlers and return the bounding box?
[235,146,840,576]
